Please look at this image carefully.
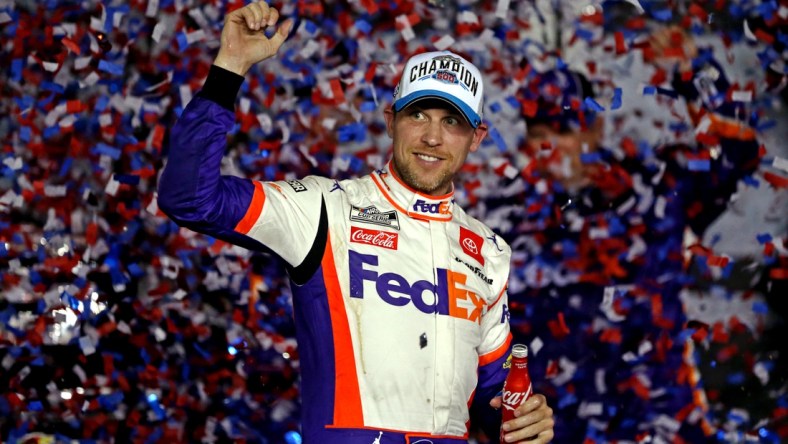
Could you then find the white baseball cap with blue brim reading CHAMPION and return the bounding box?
[393,51,484,128]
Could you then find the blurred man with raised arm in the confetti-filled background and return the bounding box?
[493,29,759,443]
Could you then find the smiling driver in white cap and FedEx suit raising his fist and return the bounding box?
[159,2,553,444]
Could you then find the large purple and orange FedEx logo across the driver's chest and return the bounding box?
[348,250,485,323]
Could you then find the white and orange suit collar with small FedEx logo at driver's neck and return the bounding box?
[372,161,454,222]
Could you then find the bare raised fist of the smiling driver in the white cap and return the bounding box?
[213,1,293,76]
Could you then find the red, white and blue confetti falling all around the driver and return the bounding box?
[0,0,788,444]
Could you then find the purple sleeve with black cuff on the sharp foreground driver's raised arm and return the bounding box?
[158,66,263,250]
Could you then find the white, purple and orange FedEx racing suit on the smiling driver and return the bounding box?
[159,67,511,444]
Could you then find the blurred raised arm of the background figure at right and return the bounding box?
[651,27,760,235]
